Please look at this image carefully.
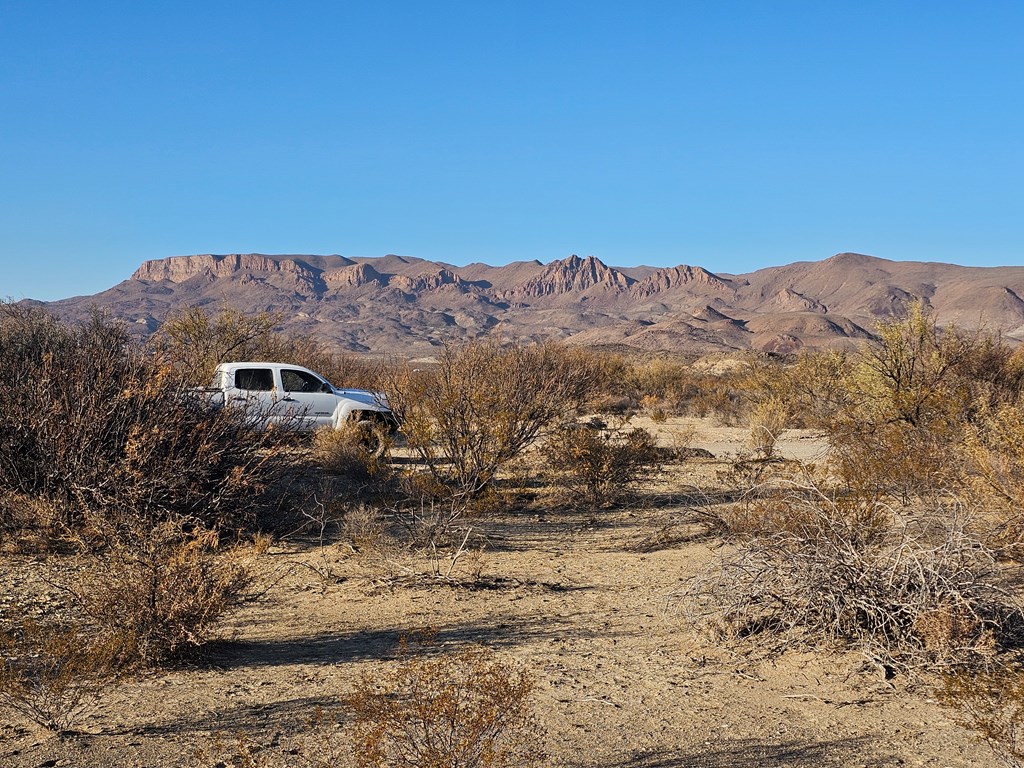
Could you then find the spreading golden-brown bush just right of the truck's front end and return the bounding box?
[385,340,591,497]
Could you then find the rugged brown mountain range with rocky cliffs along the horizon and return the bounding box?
[36,253,1024,356]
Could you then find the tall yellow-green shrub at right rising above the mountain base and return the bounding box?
[824,303,1021,502]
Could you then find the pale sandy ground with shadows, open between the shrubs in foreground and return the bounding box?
[0,420,995,768]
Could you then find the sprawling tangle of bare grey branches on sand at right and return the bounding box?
[684,486,1020,664]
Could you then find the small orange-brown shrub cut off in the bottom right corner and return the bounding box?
[937,666,1024,768]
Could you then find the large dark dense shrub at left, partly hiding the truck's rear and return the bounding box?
[0,308,291,528]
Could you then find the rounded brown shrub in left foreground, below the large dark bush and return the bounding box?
[61,521,253,667]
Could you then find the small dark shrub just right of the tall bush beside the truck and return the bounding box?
[542,423,663,507]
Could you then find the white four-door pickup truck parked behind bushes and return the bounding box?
[205,362,398,454]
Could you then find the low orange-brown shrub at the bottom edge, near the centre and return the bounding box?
[348,649,545,768]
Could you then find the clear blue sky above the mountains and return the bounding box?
[0,0,1024,299]
